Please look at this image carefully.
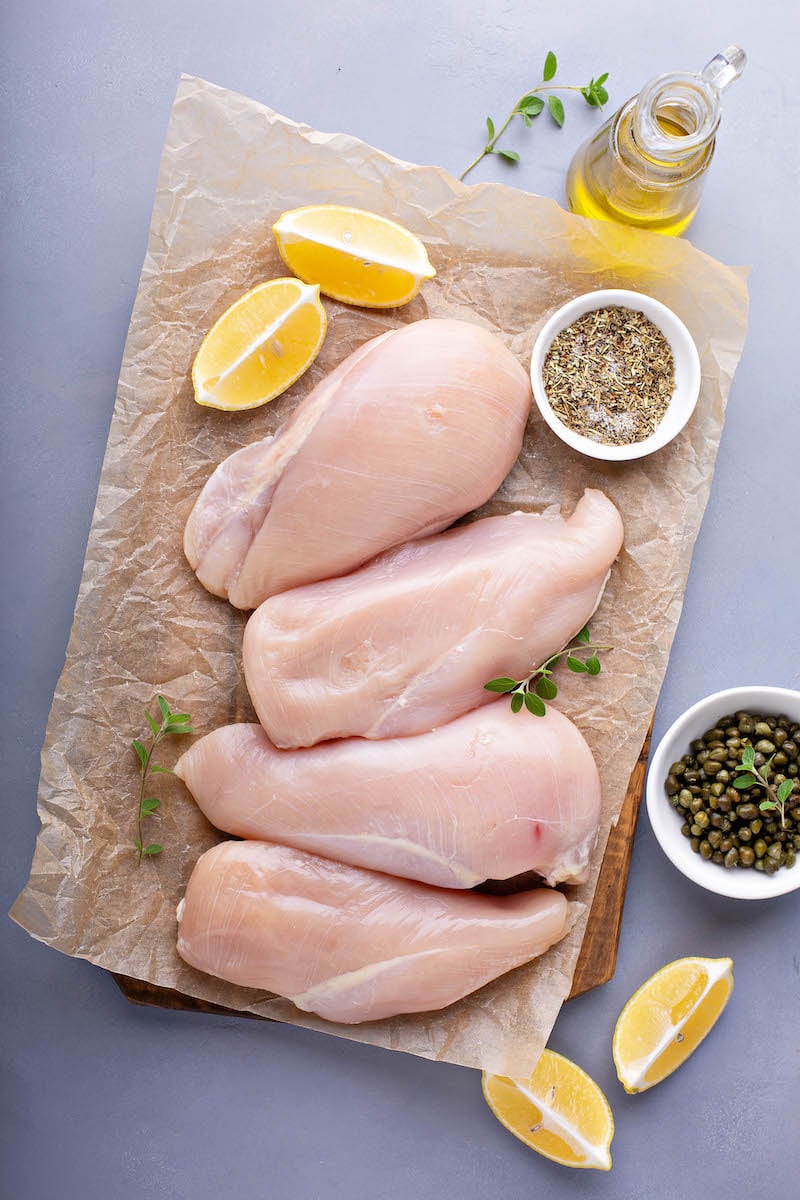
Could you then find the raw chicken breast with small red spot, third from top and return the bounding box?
[175,700,600,888]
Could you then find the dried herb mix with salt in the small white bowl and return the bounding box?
[542,306,675,446]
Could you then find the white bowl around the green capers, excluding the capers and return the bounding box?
[646,686,800,900]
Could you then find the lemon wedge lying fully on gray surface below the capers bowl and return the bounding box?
[612,958,733,1092]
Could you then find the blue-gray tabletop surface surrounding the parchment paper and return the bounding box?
[0,0,800,1200]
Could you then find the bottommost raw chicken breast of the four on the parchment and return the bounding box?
[178,841,570,1025]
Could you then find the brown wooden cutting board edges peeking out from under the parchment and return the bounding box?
[112,722,652,1021]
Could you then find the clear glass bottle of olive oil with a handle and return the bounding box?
[566,46,746,234]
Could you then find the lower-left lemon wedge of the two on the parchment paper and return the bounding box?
[192,278,327,412]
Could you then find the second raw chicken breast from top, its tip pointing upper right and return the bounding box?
[243,491,622,746]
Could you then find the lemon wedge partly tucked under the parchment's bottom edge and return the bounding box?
[483,1050,614,1171]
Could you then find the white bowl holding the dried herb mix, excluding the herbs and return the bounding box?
[530,288,700,462]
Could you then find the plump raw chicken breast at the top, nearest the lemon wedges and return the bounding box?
[184,320,530,608]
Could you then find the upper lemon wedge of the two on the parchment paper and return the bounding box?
[272,204,437,308]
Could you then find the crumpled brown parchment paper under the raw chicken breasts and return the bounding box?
[12,70,747,1074]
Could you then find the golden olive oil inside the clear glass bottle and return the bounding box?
[566,104,714,236]
